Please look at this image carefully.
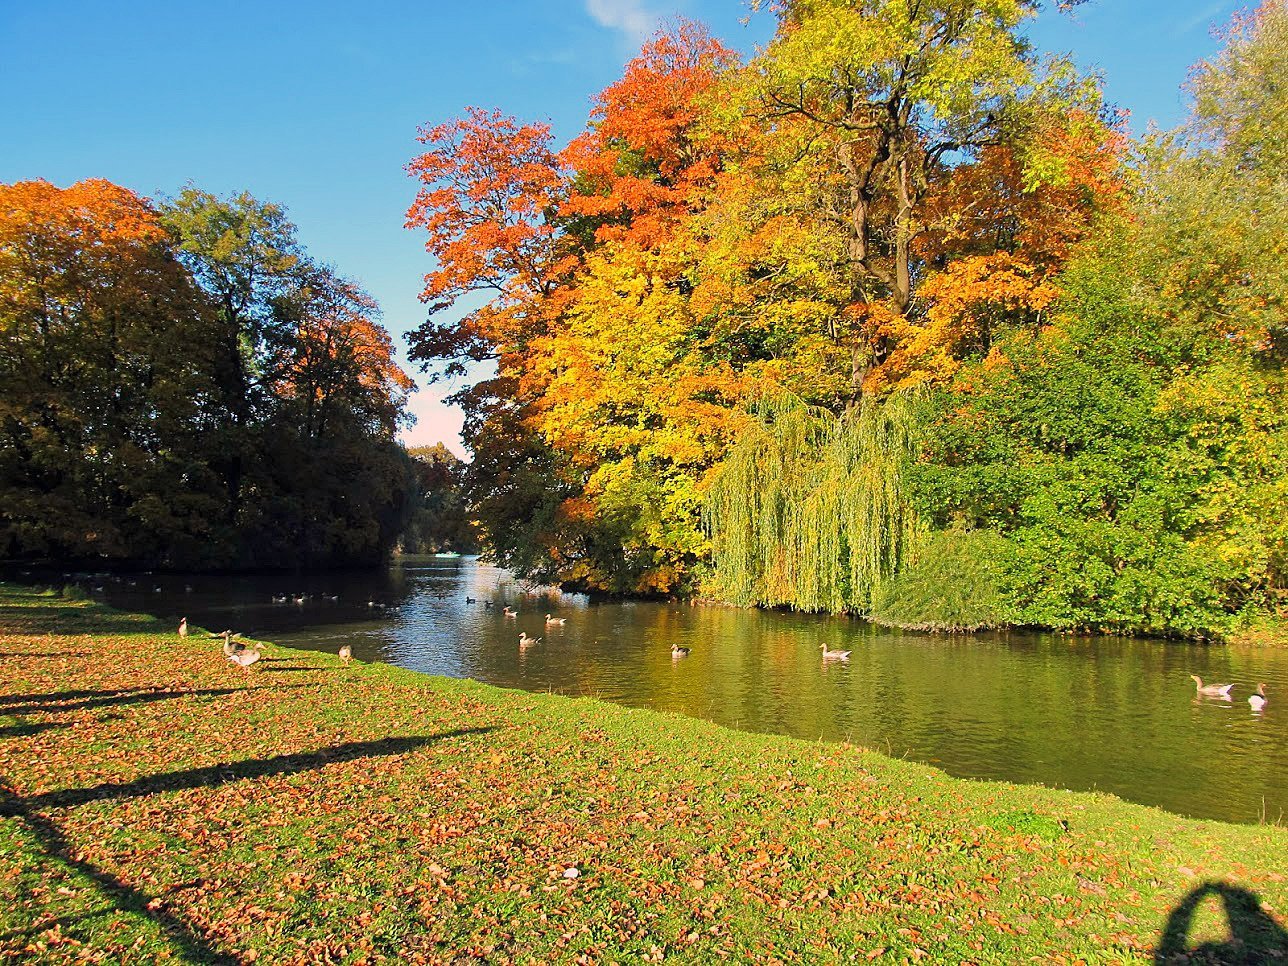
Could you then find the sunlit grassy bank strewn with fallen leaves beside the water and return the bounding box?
[0,587,1288,963]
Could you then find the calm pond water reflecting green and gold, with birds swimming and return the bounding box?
[77,558,1288,822]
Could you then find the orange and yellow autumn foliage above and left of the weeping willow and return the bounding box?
[407,0,1121,595]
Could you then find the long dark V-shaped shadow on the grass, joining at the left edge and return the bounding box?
[0,726,496,965]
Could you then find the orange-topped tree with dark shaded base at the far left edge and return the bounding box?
[0,180,222,559]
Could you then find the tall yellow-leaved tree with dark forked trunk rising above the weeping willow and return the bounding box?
[716,0,1112,401]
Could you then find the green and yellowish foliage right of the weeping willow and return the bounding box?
[916,4,1288,635]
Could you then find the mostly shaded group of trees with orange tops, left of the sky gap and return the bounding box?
[0,180,415,569]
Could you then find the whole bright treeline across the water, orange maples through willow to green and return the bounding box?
[408,0,1288,635]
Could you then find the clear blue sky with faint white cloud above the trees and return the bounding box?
[0,0,1243,450]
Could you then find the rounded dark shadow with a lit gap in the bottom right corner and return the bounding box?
[1154,882,1288,966]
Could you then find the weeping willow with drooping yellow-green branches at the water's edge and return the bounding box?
[703,395,918,613]
